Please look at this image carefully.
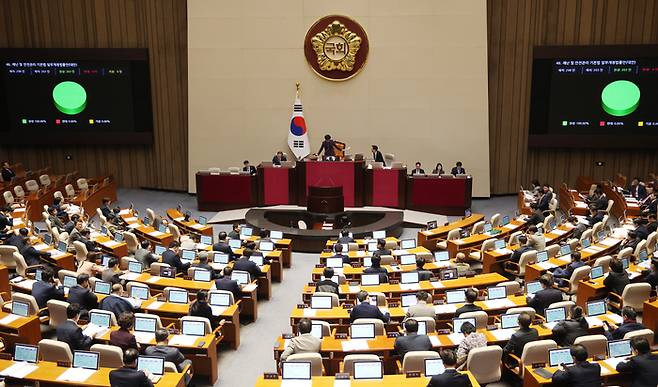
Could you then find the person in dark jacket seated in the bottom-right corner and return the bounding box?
[617,337,658,387]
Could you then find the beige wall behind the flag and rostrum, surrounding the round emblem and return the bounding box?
[188,0,489,197]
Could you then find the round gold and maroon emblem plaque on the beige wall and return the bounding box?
[304,15,369,81]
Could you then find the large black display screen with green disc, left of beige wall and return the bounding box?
[0,49,153,144]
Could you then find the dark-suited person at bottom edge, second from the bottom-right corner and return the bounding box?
[553,344,602,387]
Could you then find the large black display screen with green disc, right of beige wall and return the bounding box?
[529,46,658,148]
